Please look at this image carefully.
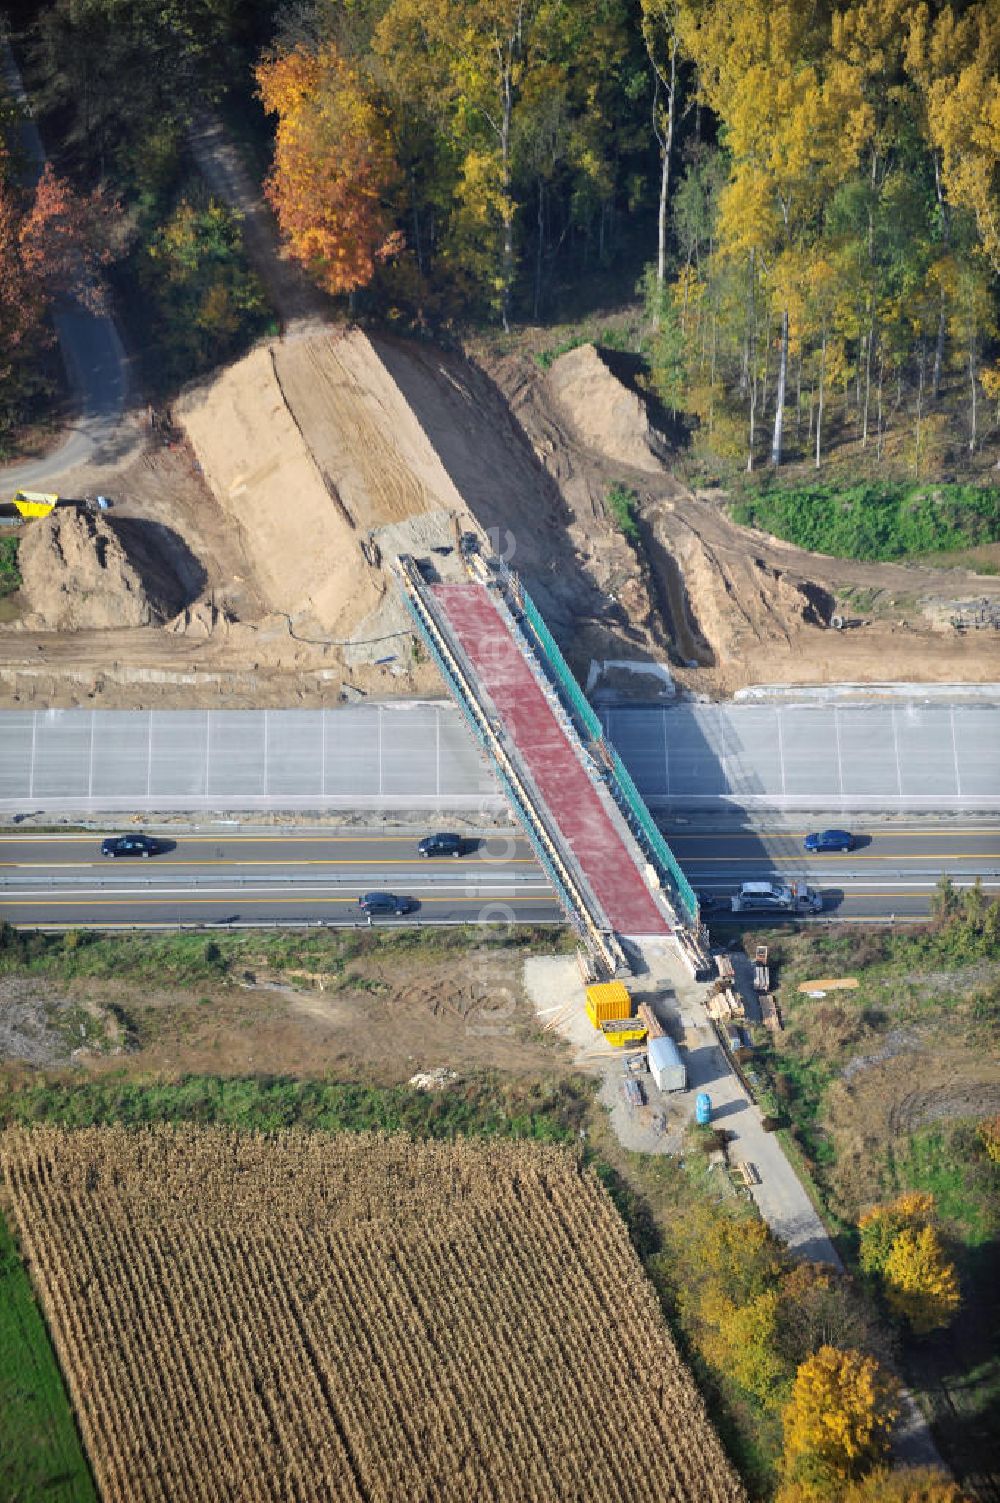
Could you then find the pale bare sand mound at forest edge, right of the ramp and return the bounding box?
[547,344,668,473]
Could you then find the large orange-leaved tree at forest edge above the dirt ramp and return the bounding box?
[257,42,402,293]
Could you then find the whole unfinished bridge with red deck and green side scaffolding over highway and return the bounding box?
[395,540,698,974]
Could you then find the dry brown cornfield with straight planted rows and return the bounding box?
[0,1127,744,1503]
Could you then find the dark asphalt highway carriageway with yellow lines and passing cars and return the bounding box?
[0,818,1000,927]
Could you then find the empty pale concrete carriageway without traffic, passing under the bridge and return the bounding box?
[0,700,1000,815]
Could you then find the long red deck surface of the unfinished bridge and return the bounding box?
[433,585,671,935]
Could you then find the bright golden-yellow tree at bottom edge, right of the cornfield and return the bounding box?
[783,1347,899,1497]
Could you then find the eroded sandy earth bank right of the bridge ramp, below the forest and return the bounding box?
[478,347,1000,694]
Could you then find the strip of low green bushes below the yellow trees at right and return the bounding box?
[732,482,1000,559]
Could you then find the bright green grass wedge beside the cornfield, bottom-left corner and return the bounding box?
[0,1219,98,1503]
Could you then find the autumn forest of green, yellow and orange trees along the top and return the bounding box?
[0,0,1000,476]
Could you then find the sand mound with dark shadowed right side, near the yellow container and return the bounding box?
[18,508,185,631]
